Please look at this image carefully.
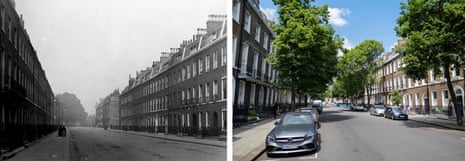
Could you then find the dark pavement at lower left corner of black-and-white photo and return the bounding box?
[7,131,70,161]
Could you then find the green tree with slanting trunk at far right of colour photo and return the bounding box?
[395,0,465,125]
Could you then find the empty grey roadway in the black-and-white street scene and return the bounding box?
[69,127,226,161]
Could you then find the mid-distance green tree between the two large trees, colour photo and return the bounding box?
[337,40,384,104]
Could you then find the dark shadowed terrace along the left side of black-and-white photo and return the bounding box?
[0,0,59,154]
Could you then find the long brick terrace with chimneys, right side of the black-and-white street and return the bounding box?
[120,15,227,136]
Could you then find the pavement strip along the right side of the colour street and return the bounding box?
[409,115,465,131]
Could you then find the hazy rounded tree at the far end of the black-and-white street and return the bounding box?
[56,92,87,124]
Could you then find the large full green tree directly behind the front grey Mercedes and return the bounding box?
[267,0,342,106]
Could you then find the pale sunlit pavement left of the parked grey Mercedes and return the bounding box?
[233,118,278,161]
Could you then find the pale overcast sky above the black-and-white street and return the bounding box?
[16,0,227,114]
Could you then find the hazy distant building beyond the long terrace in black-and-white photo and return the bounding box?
[95,89,120,129]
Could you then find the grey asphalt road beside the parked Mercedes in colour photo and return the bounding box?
[257,108,465,161]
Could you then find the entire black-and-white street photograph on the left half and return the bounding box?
[0,0,230,161]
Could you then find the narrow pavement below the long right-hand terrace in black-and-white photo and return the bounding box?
[108,129,226,147]
